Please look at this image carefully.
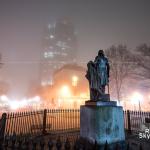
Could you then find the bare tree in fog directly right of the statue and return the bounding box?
[105,45,135,101]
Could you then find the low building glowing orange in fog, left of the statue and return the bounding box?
[53,64,89,108]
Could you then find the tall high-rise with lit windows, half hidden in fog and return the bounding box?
[40,18,77,85]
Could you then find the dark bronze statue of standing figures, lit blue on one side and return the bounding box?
[86,50,109,101]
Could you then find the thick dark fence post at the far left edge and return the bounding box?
[0,113,7,142]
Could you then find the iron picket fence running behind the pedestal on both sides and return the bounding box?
[0,109,150,140]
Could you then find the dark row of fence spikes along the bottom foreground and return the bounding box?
[0,135,147,150]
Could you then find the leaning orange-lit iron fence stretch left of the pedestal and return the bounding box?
[4,109,80,136]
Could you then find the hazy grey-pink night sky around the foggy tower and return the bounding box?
[0,0,150,97]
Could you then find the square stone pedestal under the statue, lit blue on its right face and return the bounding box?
[80,101,125,145]
